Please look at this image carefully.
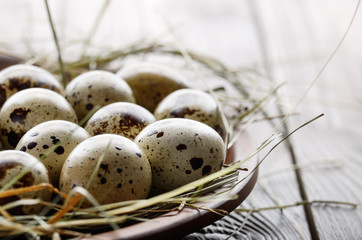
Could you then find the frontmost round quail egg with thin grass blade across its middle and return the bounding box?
[60,134,152,206]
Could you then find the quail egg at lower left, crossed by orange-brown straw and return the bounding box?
[0,150,51,214]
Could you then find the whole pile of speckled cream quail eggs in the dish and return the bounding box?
[0,64,226,213]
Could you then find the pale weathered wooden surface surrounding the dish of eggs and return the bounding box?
[0,0,362,240]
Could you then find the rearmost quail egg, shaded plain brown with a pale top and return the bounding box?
[117,64,186,112]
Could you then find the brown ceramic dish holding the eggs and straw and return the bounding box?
[0,53,258,239]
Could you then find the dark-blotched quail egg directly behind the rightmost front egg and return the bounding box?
[154,88,226,141]
